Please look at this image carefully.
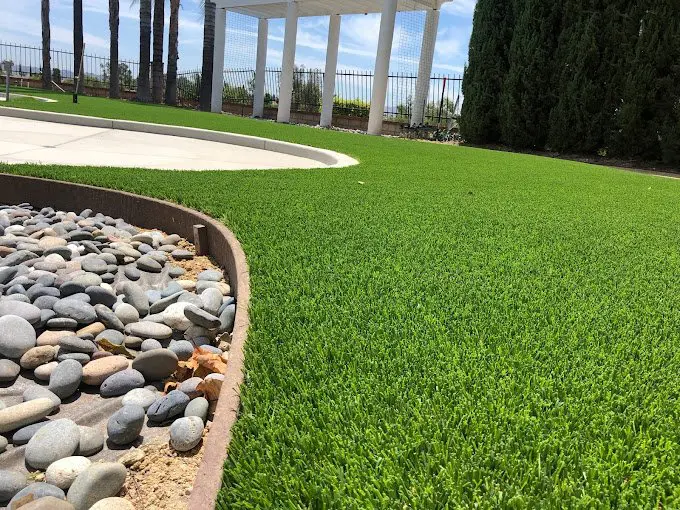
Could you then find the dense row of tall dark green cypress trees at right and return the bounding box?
[460,0,680,164]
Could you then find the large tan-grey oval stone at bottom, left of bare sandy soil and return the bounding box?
[67,462,127,510]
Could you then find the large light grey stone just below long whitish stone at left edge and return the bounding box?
[24,419,80,469]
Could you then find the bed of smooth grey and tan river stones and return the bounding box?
[0,204,236,510]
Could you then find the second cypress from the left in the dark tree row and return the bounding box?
[500,0,562,149]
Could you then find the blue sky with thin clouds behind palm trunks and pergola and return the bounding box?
[0,0,476,74]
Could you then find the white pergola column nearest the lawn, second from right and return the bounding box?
[368,0,397,135]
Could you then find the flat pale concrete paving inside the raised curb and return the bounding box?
[0,116,327,170]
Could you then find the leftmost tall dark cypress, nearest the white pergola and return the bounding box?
[460,0,514,143]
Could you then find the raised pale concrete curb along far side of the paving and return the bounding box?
[0,106,359,168]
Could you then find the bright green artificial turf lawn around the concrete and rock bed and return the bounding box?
[0,90,680,509]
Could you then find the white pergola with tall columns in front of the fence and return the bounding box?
[212,0,451,135]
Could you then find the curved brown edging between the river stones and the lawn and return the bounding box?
[0,173,250,510]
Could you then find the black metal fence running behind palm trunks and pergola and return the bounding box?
[0,42,462,124]
